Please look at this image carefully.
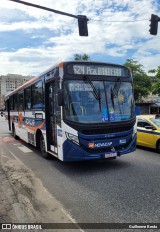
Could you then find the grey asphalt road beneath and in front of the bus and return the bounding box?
[0,118,160,228]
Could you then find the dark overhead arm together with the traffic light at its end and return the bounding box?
[9,0,89,36]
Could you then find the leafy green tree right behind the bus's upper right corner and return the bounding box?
[124,59,151,102]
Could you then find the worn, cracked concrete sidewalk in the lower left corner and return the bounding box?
[0,118,83,232]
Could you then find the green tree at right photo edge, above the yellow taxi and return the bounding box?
[148,66,160,96]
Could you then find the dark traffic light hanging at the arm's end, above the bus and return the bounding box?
[78,15,88,36]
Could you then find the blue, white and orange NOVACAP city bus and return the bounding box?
[5,61,137,161]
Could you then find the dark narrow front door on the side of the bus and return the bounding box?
[45,81,58,155]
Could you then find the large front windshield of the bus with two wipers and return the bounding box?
[64,78,134,123]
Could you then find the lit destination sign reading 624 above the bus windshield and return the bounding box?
[68,64,129,77]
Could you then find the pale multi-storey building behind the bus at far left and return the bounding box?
[0,74,33,110]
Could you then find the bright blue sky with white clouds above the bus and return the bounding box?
[0,0,160,76]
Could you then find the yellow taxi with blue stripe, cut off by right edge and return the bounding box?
[137,115,160,153]
